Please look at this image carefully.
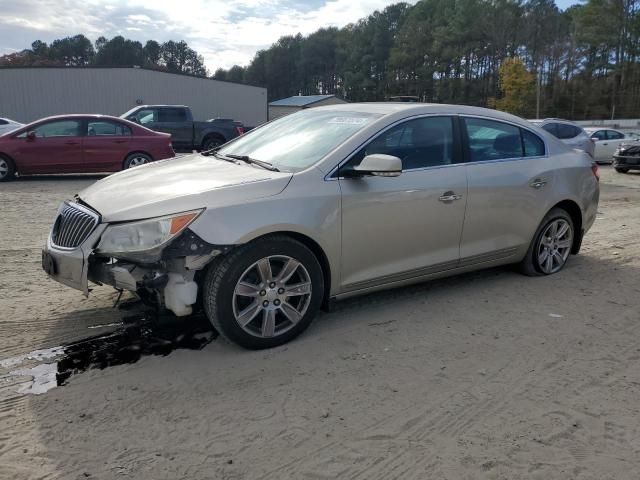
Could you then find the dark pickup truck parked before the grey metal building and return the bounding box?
[120,105,244,151]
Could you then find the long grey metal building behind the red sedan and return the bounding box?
[0,67,267,126]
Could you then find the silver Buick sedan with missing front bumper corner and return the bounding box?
[42,103,599,348]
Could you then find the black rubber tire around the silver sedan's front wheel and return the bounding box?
[202,235,324,350]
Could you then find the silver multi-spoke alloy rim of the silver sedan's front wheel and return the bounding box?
[233,255,311,338]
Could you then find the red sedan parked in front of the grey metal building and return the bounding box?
[0,115,175,181]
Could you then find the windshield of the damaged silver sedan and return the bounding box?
[219,109,380,171]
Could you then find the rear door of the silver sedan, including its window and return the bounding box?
[460,116,554,266]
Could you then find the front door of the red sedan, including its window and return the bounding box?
[15,118,84,173]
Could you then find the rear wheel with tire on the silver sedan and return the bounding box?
[520,208,574,276]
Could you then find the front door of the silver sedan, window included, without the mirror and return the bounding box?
[339,116,467,292]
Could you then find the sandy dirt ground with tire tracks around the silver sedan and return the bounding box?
[0,167,640,480]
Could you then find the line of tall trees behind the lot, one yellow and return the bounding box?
[0,0,640,119]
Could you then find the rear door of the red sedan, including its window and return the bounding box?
[83,118,131,172]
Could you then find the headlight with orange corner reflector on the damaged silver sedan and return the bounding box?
[97,210,202,254]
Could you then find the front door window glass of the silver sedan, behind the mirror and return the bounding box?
[347,117,453,171]
